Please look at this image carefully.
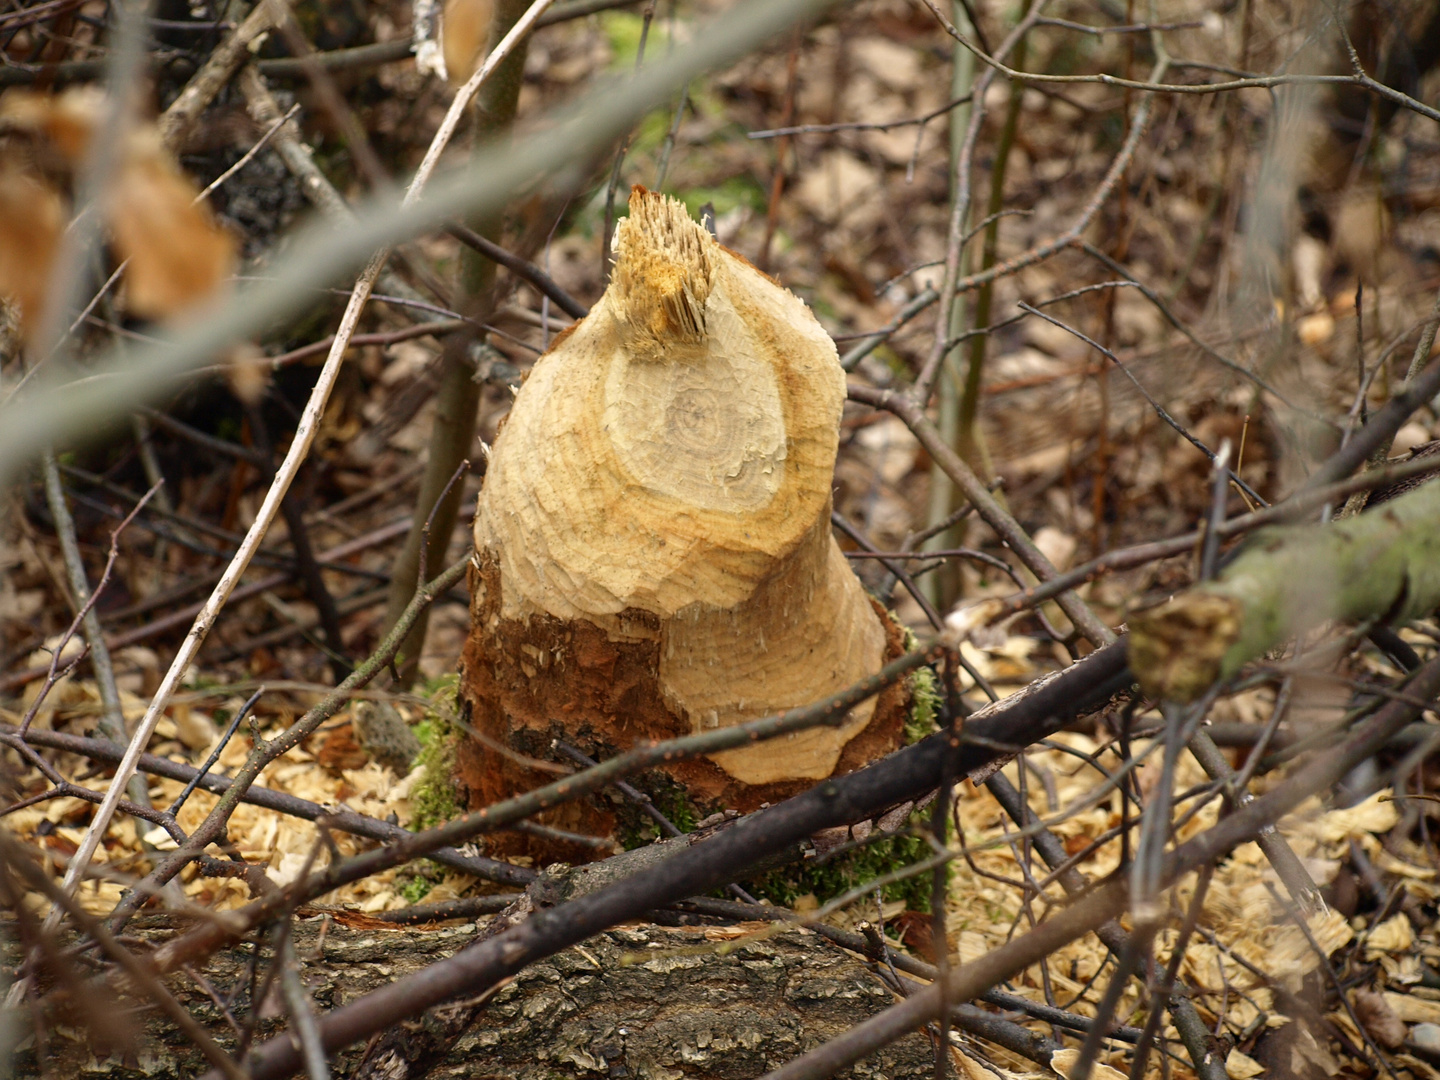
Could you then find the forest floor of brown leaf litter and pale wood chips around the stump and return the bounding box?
[0,0,1440,1080]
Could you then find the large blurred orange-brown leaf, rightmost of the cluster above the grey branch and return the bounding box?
[108,132,235,318]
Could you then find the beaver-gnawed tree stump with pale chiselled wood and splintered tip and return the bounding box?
[459,187,907,852]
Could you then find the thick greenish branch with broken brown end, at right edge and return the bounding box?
[1130,484,1440,701]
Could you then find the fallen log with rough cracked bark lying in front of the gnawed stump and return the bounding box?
[3,917,935,1080]
